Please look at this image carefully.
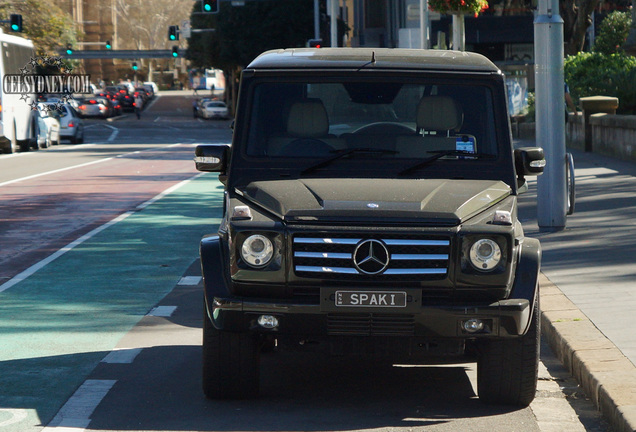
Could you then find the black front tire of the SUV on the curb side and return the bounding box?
[477,294,541,407]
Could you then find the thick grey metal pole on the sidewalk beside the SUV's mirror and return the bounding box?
[534,0,567,230]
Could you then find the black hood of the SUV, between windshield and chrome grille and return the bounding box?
[240,179,511,226]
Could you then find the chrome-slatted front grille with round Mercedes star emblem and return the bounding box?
[293,234,450,282]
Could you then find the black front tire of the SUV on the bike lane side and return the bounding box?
[202,313,260,399]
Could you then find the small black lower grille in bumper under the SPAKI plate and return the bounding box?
[327,313,415,336]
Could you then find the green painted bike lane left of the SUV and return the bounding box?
[0,174,223,432]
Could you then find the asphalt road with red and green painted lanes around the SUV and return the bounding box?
[0,94,607,432]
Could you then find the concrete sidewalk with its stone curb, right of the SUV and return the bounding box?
[516,141,636,432]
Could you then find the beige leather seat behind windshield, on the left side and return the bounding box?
[267,99,346,157]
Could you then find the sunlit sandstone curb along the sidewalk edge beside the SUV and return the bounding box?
[539,273,636,432]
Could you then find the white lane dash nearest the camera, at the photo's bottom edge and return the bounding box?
[42,380,117,432]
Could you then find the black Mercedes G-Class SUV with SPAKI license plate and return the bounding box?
[195,48,545,406]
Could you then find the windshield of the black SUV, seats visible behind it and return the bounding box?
[245,77,497,159]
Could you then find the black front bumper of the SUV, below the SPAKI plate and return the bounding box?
[207,297,532,339]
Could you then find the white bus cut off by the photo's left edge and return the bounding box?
[0,29,37,153]
